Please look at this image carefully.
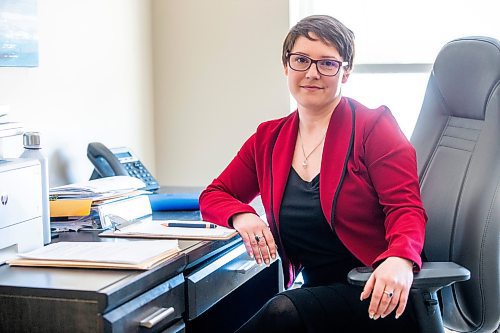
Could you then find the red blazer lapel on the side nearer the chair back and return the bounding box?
[320,98,354,228]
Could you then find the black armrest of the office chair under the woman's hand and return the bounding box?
[347,262,470,290]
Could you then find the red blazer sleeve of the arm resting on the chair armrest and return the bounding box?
[365,108,427,270]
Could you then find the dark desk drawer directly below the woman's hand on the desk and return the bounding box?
[186,244,266,320]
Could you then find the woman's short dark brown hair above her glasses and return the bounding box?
[281,15,354,69]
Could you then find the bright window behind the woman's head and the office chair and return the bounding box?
[290,0,500,137]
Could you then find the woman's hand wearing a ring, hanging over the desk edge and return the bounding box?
[233,213,276,266]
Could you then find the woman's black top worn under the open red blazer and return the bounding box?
[279,168,363,285]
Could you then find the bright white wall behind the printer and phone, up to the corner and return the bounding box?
[0,0,155,186]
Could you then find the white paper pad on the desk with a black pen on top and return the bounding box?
[99,217,238,240]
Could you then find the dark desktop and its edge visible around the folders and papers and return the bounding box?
[0,211,241,312]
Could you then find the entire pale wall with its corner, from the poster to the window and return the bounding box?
[0,0,289,186]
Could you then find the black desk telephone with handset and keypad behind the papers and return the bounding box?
[87,142,160,191]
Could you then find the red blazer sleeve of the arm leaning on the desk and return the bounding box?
[200,134,259,227]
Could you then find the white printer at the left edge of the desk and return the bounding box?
[0,157,43,265]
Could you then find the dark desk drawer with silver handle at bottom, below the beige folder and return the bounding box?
[103,274,185,332]
